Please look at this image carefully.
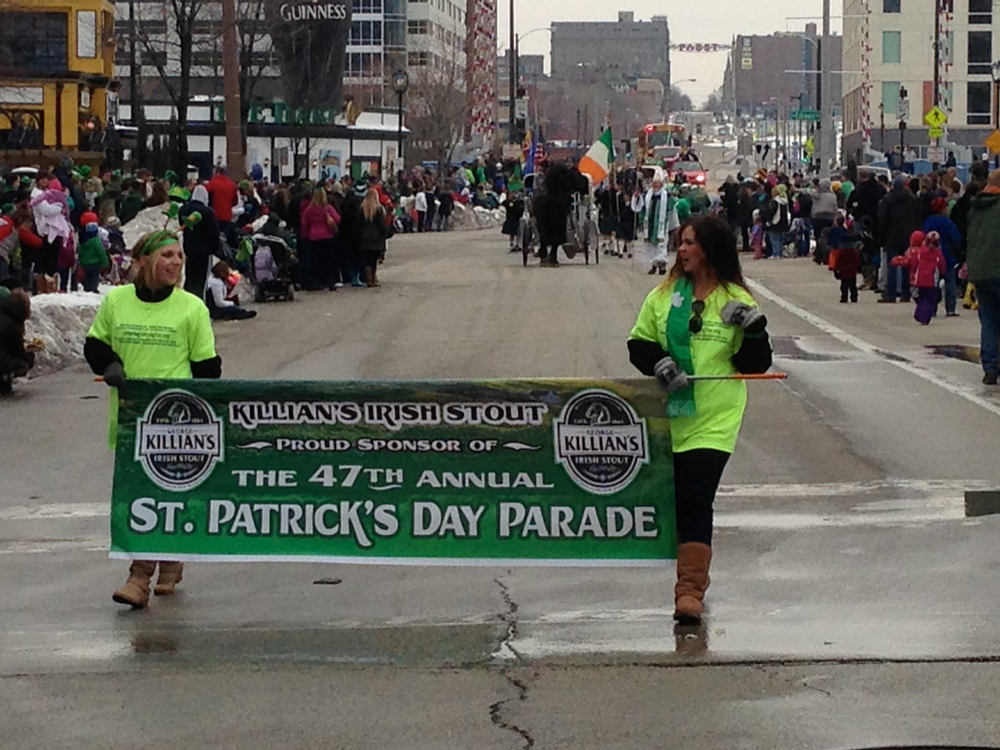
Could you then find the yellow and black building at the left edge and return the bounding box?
[0,0,116,166]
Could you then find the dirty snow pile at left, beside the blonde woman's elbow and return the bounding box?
[25,292,103,376]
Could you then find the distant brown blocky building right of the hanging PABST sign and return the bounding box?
[722,24,844,119]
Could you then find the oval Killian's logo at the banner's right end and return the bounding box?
[553,389,649,495]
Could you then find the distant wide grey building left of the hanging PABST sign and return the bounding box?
[551,11,670,90]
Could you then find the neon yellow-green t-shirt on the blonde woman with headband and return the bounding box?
[87,284,216,450]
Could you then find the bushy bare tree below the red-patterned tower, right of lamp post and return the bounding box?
[406,58,468,173]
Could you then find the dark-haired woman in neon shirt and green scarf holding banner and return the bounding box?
[628,216,771,624]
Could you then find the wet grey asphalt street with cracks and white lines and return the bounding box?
[0,232,1000,750]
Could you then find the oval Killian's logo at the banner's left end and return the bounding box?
[135,390,223,492]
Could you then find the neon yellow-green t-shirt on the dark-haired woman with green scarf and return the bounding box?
[629,282,756,453]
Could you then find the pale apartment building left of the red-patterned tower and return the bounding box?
[406,0,467,76]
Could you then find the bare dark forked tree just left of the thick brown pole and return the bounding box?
[133,0,206,175]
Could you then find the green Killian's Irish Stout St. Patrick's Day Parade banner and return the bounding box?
[111,380,676,566]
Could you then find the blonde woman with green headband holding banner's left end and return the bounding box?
[83,232,222,609]
